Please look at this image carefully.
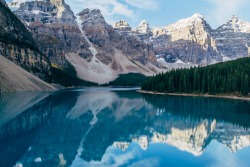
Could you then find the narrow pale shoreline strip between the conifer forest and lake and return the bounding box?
[137,90,250,101]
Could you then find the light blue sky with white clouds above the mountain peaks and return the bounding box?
[6,0,250,28]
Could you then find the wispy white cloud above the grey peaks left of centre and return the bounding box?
[65,0,159,23]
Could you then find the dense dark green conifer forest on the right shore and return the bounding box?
[142,57,250,96]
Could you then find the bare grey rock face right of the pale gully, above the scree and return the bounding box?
[78,9,156,64]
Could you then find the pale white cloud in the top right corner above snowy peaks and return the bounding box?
[206,0,249,25]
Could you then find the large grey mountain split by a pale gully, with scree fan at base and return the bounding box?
[9,0,161,84]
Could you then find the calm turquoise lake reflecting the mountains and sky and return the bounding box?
[0,88,250,167]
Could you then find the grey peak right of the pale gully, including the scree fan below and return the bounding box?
[67,9,159,83]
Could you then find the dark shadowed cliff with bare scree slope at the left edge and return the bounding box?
[0,1,54,91]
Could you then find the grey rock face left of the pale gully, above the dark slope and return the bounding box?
[10,0,90,68]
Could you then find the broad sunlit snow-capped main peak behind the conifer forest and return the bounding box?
[152,14,222,64]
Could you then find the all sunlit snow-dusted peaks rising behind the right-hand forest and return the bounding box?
[116,13,250,69]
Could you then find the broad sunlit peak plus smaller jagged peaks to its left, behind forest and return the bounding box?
[114,14,222,69]
